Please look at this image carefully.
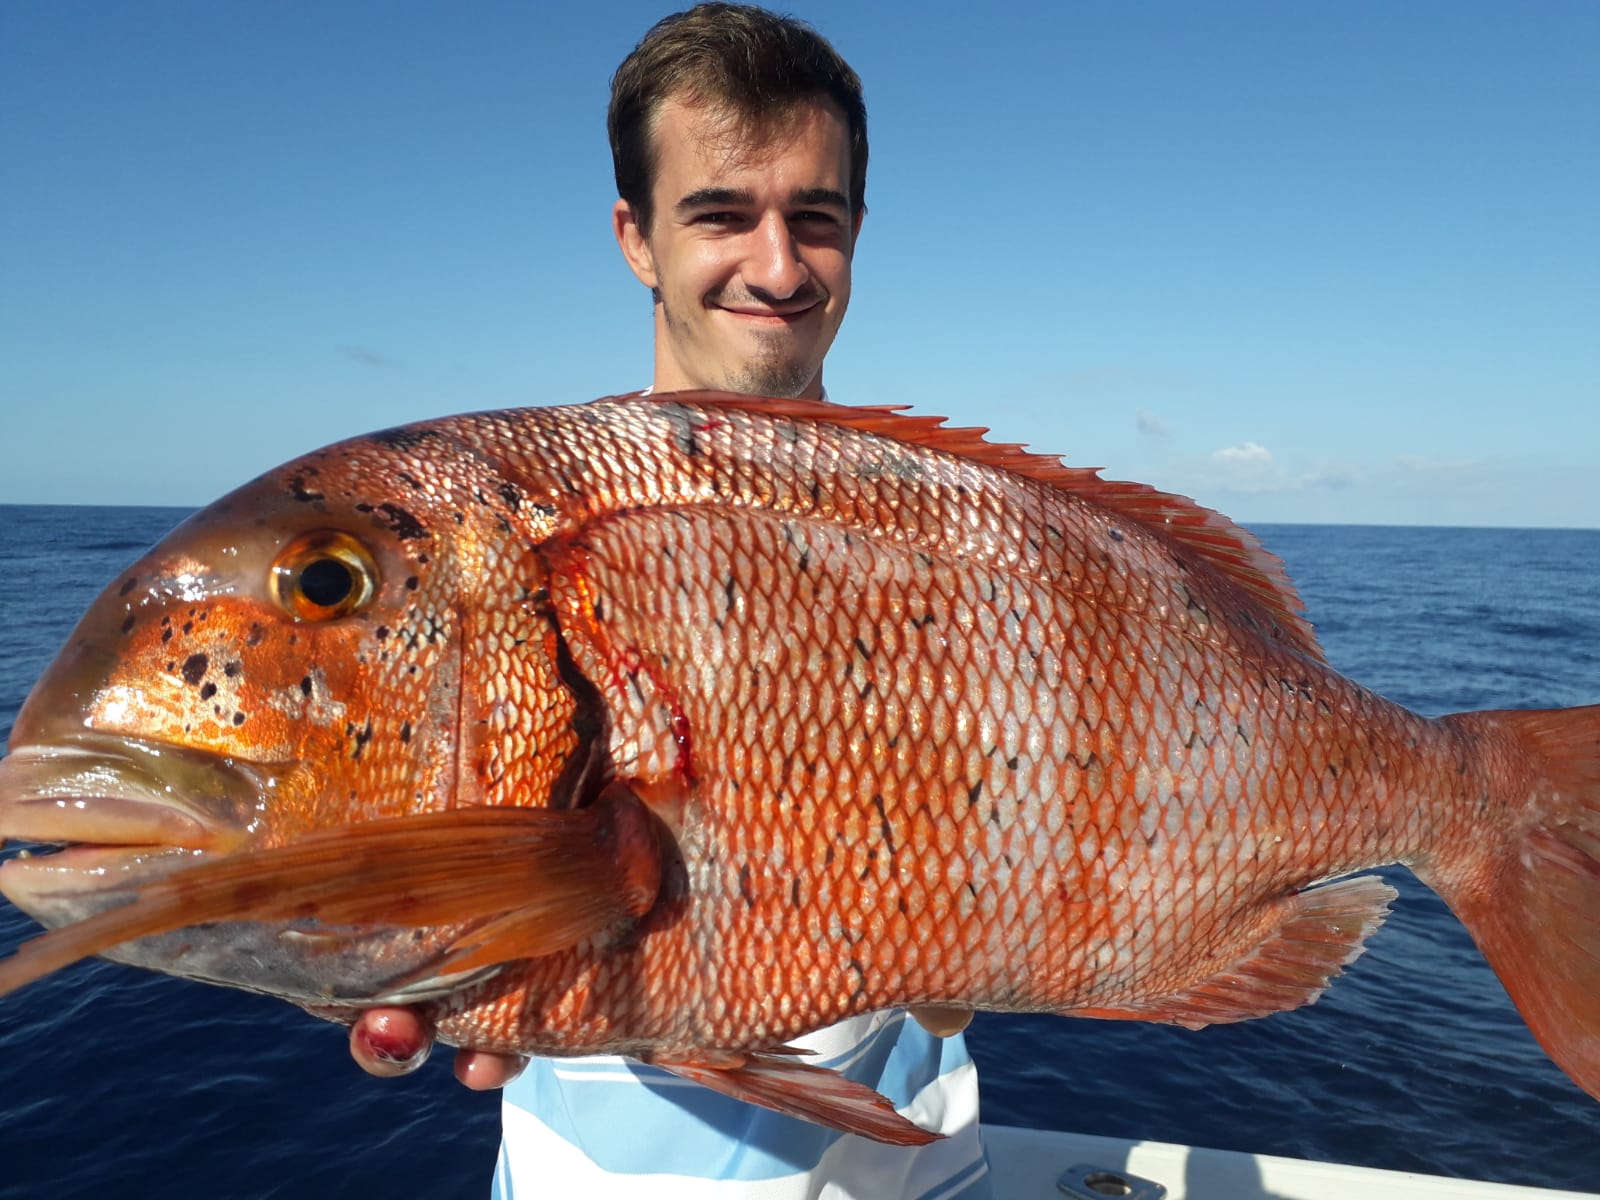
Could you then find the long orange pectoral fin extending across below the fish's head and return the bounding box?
[0,798,659,995]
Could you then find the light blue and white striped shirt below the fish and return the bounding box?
[491,1011,990,1200]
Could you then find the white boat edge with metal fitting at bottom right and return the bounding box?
[984,1125,1597,1200]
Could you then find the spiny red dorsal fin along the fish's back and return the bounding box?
[610,392,1326,662]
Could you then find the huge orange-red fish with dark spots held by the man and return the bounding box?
[0,394,1600,1142]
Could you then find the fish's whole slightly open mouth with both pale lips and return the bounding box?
[0,733,269,926]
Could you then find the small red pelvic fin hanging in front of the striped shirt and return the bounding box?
[651,1054,944,1146]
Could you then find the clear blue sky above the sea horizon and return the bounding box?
[0,0,1600,526]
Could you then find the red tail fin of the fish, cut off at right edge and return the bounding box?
[1413,704,1600,1099]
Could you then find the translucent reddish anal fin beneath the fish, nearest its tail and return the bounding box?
[1072,875,1397,1029]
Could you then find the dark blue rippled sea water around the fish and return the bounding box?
[0,507,1600,1200]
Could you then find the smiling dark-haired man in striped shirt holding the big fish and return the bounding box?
[352,3,989,1200]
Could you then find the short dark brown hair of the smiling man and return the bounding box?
[606,3,867,234]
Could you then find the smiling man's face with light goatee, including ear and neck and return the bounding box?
[613,99,861,398]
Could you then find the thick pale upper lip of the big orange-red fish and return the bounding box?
[0,733,270,851]
